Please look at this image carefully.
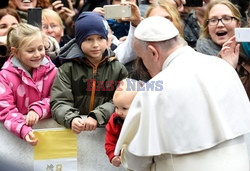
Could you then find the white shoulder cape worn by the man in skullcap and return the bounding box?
[115,46,250,170]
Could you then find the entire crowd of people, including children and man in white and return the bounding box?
[0,0,250,171]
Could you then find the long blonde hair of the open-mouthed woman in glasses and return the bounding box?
[200,0,241,38]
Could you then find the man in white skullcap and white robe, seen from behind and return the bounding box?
[115,16,250,171]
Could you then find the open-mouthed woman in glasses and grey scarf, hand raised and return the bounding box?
[196,0,250,99]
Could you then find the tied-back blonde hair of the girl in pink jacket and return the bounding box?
[7,23,43,50]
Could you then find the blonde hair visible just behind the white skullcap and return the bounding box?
[145,0,184,37]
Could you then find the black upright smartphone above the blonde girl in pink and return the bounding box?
[27,8,42,28]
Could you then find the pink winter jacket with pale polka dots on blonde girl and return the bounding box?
[0,56,57,138]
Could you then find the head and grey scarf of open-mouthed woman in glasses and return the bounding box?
[196,0,241,56]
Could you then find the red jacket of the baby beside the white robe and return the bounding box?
[105,113,123,162]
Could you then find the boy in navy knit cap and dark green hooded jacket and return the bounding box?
[51,12,127,134]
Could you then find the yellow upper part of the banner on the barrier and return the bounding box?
[34,128,77,160]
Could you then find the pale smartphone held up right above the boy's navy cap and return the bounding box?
[103,4,131,19]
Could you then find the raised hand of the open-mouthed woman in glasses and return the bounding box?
[219,36,240,68]
